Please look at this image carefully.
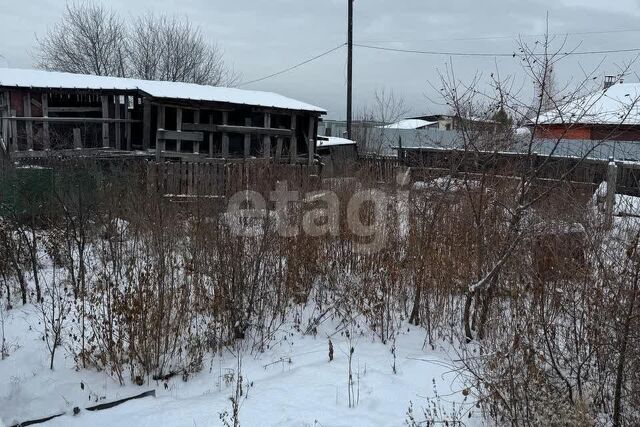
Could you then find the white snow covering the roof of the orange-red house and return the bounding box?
[538,83,640,125]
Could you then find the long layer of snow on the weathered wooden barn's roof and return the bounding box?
[0,68,326,113]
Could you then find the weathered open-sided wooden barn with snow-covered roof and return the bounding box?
[0,68,326,164]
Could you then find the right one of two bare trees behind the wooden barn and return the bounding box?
[128,13,237,86]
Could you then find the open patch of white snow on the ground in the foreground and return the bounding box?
[0,305,470,427]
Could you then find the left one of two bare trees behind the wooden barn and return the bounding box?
[36,3,127,77]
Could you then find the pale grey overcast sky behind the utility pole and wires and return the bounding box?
[0,0,640,118]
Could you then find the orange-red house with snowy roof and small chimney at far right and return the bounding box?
[529,77,640,141]
